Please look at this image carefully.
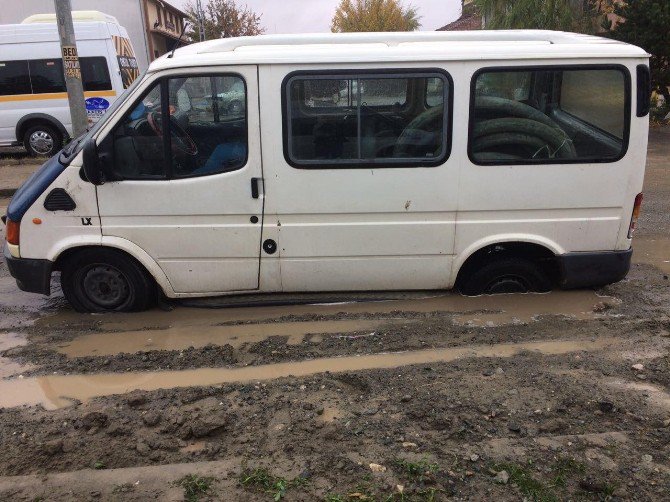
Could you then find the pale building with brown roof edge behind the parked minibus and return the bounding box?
[0,0,188,71]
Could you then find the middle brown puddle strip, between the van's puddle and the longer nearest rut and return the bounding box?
[57,320,394,357]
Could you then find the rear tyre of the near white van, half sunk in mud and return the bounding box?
[459,257,552,296]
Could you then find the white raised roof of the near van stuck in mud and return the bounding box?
[149,30,649,71]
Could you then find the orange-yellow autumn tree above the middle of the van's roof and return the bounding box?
[331,0,421,33]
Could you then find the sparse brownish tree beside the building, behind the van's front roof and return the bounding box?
[186,0,265,42]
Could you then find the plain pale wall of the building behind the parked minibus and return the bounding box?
[0,0,151,71]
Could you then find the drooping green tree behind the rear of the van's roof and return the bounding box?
[475,0,614,33]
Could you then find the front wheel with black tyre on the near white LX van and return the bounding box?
[61,249,157,312]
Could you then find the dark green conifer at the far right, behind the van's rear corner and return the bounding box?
[609,0,670,103]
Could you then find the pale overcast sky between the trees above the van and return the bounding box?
[168,0,461,34]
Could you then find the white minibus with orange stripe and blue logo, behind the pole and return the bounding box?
[0,11,139,156]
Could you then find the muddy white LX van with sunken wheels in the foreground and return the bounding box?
[0,31,650,311]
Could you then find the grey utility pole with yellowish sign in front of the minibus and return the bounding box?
[54,0,88,138]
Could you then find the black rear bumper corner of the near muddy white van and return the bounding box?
[556,248,633,289]
